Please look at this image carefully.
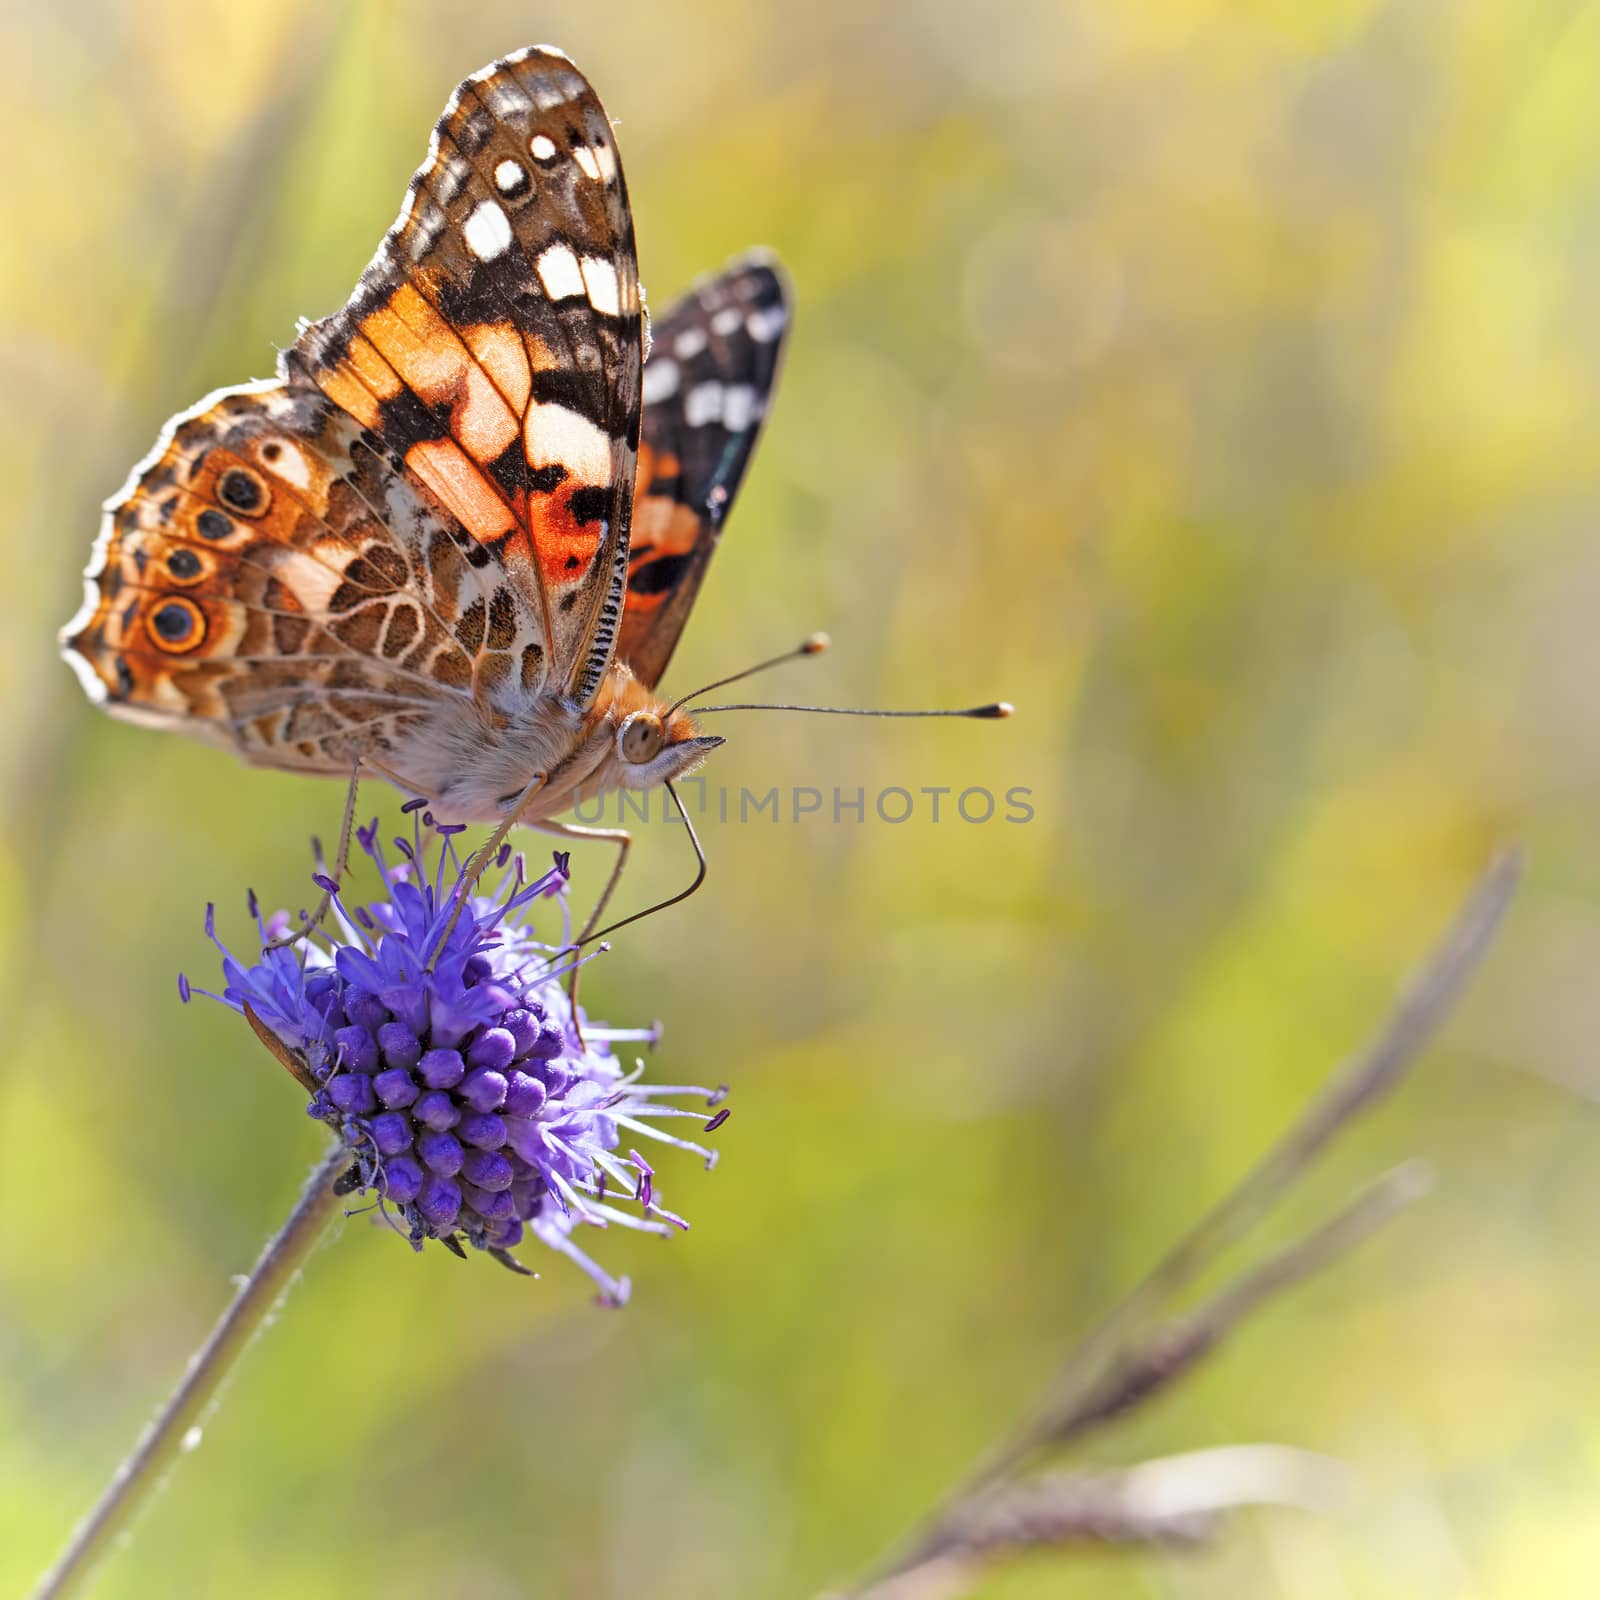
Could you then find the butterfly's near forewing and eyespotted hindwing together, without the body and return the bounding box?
[61,50,642,774]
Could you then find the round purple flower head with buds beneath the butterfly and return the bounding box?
[179,805,726,1306]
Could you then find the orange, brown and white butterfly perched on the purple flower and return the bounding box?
[61,46,790,915]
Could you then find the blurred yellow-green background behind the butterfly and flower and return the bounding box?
[0,0,1600,1600]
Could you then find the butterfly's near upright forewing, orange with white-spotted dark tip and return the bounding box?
[285,48,643,709]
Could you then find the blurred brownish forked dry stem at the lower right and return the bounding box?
[848,851,1522,1600]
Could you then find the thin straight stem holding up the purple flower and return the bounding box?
[34,1146,350,1600]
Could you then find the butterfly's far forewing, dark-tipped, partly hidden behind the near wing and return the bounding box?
[618,254,790,686]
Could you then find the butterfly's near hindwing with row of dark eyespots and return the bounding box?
[61,382,483,773]
